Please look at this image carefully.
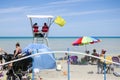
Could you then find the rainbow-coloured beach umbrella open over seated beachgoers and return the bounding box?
[72,36,101,50]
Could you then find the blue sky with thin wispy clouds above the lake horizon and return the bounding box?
[0,0,120,37]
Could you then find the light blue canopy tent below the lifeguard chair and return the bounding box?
[23,43,56,69]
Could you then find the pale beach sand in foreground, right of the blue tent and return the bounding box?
[36,61,120,80]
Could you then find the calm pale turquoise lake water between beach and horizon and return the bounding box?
[0,37,120,56]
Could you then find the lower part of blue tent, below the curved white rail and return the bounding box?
[33,54,56,69]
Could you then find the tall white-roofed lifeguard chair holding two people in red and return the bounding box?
[27,15,54,46]
